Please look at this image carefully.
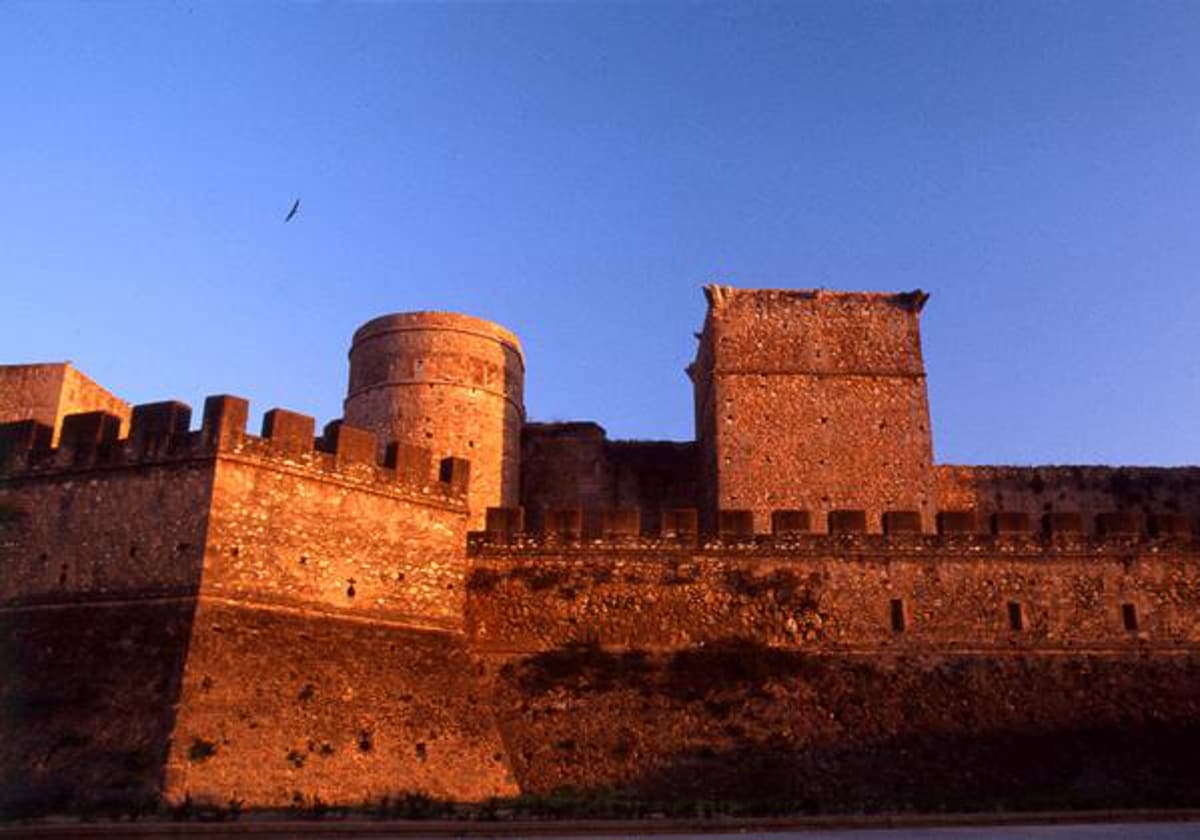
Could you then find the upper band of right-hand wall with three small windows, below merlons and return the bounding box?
[467,536,1200,652]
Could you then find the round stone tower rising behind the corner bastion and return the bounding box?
[346,312,524,528]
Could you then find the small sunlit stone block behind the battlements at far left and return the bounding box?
[0,362,130,444]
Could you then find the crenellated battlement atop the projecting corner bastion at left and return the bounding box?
[0,395,470,505]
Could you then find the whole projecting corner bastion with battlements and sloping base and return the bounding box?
[0,396,515,809]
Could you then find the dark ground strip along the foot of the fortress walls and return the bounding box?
[0,811,1200,840]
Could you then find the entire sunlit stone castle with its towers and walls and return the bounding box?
[0,286,1200,814]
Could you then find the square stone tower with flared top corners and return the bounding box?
[688,286,937,532]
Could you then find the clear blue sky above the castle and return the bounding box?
[0,0,1200,464]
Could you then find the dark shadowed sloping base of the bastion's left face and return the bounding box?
[0,599,196,818]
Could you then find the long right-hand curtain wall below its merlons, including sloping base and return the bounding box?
[467,535,1200,811]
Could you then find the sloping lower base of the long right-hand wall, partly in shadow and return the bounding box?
[497,641,1200,812]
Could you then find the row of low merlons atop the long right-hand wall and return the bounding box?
[468,508,1200,554]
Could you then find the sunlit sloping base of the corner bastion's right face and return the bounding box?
[164,600,517,806]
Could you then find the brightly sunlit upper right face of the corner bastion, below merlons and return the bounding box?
[203,442,467,629]
